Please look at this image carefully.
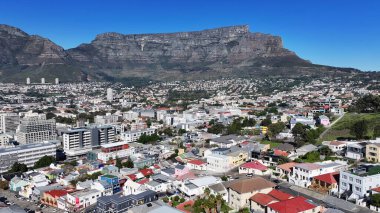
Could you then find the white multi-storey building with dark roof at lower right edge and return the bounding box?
[339,164,380,200]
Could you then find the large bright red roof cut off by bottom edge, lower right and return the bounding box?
[268,196,317,213]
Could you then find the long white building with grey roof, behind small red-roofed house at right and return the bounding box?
[289,161,348,187]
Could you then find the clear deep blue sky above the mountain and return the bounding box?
[0,0,380,71]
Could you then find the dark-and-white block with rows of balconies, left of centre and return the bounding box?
[62,125,115,159]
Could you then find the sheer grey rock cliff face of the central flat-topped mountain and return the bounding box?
[68,26,308,71]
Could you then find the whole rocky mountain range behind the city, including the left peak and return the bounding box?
[0,25,358,81]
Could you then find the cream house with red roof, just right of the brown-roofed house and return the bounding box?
[250,189,293,212]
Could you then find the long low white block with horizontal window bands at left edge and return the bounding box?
[0,141,59,173]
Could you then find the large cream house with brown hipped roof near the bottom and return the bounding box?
[227,177,276,210]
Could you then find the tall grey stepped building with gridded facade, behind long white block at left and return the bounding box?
[16,114,57,144]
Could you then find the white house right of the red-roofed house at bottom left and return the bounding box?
[66,189,102,212]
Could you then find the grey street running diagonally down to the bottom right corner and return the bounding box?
[279,182,375,213]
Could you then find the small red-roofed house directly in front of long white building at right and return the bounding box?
[309,172,339,195]
